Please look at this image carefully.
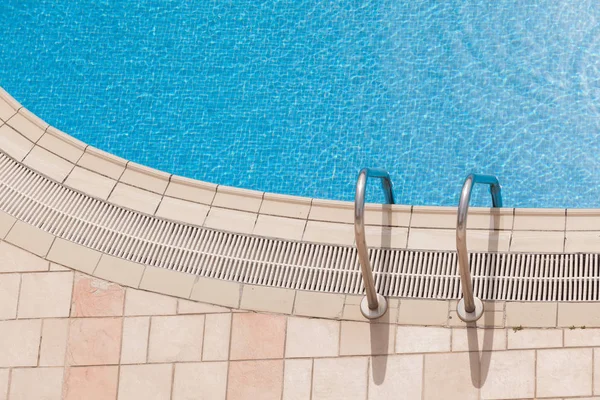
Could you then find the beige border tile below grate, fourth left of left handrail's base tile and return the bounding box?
[140,266,196,298]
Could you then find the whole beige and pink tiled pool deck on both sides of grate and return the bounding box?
[0,84,600,400]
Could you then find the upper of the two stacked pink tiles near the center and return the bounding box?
[230,313,286,360]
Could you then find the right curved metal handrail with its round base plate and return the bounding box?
[456,174,502,322]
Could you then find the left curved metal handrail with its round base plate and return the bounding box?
[354,168,394,319]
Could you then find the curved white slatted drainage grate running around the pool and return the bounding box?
[0,152,600,301]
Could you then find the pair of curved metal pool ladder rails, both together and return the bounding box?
[354,168,502,322]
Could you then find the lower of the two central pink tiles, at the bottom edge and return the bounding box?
[227,360,283,400]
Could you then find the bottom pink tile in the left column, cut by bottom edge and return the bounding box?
[63,366,119,400]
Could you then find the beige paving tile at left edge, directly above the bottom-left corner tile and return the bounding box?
[0,319,42,367]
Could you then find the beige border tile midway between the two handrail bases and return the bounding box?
[398,299,448,325]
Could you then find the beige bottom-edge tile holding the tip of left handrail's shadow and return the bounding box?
[368,355,423,400]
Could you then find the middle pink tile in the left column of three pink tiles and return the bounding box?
[67,318,123,365]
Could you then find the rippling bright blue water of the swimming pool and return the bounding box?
[0,0,600,208]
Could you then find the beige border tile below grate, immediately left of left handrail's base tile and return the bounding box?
[294,290,345,319]
